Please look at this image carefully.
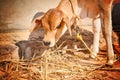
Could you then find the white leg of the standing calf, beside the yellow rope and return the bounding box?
[90,18,101,58]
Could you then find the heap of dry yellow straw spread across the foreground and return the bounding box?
[0,47,106,80]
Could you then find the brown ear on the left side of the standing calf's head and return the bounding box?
[30,19,42,32]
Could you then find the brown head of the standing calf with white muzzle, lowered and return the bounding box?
[32,9,71,47]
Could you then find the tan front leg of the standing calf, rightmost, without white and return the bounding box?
[102,8,114,65]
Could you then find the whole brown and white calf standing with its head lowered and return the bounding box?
[29,0,114,65]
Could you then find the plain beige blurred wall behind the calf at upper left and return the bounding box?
[0,0,60,30]
